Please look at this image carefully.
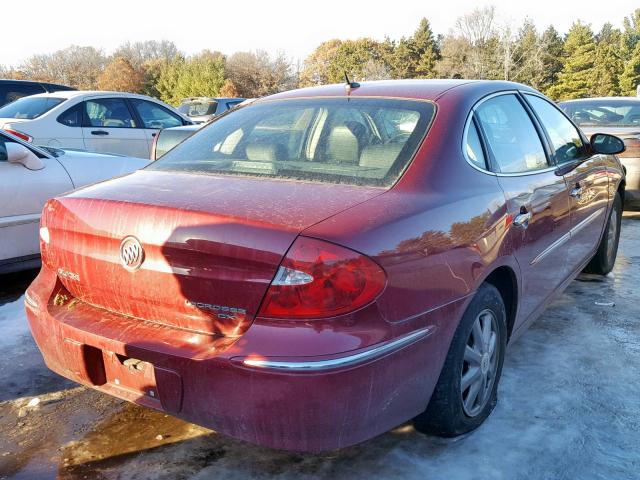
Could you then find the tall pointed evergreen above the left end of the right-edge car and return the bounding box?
[549,23,596,100]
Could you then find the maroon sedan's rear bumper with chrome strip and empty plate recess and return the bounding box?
[25,273,466,451]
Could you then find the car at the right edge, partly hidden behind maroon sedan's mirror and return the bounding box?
[559,97,640,207]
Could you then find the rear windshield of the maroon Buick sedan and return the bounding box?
[149,98,435,186]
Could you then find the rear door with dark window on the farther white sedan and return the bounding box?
[82,97,150,158]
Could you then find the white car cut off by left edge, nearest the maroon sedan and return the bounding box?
[0,132,149,273]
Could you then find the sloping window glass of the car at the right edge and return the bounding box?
[560,99,640,127]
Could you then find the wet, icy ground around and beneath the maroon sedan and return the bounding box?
[0,214,640,480]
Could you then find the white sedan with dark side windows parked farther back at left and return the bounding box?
[0,91,193,158]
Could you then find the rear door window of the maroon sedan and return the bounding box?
[474,94,549,173]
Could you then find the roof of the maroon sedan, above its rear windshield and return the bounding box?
[259,79,533,101]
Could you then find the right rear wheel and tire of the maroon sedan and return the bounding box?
[413,283,507,437]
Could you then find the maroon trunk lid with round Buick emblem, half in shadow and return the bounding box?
[43,171,383,336]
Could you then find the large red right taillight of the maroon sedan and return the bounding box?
[259,237,387,318]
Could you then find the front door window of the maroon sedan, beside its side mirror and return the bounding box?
[527,94,585,163]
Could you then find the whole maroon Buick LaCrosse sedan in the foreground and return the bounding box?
[26,80,625,451]
